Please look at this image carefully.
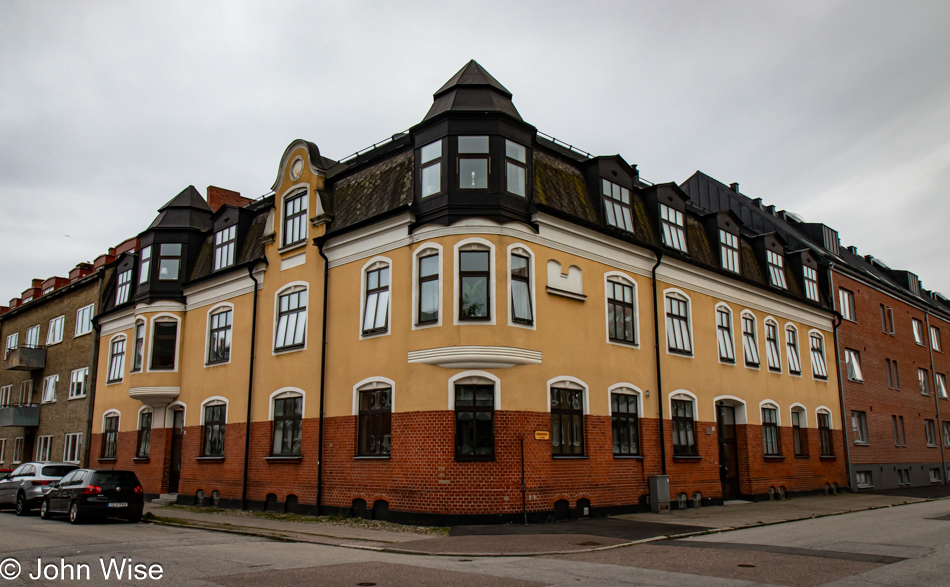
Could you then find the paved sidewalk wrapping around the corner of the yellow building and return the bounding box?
[145,491,947,557]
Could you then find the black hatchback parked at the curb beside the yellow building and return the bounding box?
[40,469,145,524]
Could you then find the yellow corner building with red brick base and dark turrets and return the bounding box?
[92,62,847,523]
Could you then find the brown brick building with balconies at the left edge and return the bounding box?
[0,262,111,468]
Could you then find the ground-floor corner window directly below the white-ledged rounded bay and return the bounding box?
[455,385,495,459]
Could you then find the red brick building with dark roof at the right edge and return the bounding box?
[682,172,950,491]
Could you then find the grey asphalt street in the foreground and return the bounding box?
[0,500,950,587]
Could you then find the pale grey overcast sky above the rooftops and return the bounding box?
[0,0,950,304]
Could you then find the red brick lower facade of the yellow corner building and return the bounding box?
[92,411,847,520]
